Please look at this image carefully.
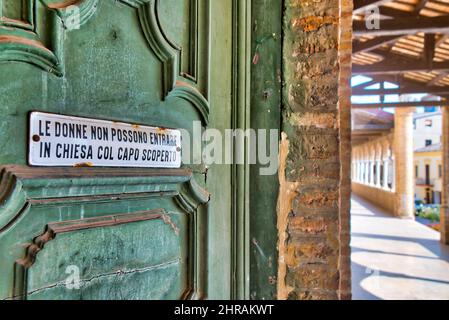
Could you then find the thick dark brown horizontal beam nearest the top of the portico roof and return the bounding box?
[353,15,449,36]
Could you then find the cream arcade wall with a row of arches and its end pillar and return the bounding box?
[352,108,414,218]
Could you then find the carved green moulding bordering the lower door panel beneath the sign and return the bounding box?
[0,166,210,300]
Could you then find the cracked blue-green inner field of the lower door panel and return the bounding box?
[26,213,189,300]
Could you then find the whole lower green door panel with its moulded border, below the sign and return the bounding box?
[0,166,209,299]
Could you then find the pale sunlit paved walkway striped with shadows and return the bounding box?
[351,196,449,300]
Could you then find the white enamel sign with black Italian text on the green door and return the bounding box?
[28,112,181,168]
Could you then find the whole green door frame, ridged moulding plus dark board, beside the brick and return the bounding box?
[231,0,283,300]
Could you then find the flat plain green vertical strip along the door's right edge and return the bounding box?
[207,0,232,299]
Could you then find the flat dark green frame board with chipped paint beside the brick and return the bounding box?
[250,0,283,299]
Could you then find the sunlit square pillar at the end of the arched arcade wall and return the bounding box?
[394,108,415,219]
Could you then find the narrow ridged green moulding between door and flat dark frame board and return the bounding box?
[231,0,251,300]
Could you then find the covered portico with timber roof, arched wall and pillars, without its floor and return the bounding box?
[352,0,449,244]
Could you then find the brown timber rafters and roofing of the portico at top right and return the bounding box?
[353,0,449,107]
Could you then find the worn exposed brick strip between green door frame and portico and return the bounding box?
[278,0,352,299]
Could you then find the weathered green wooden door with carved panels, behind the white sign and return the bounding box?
[0,0,233,299]
